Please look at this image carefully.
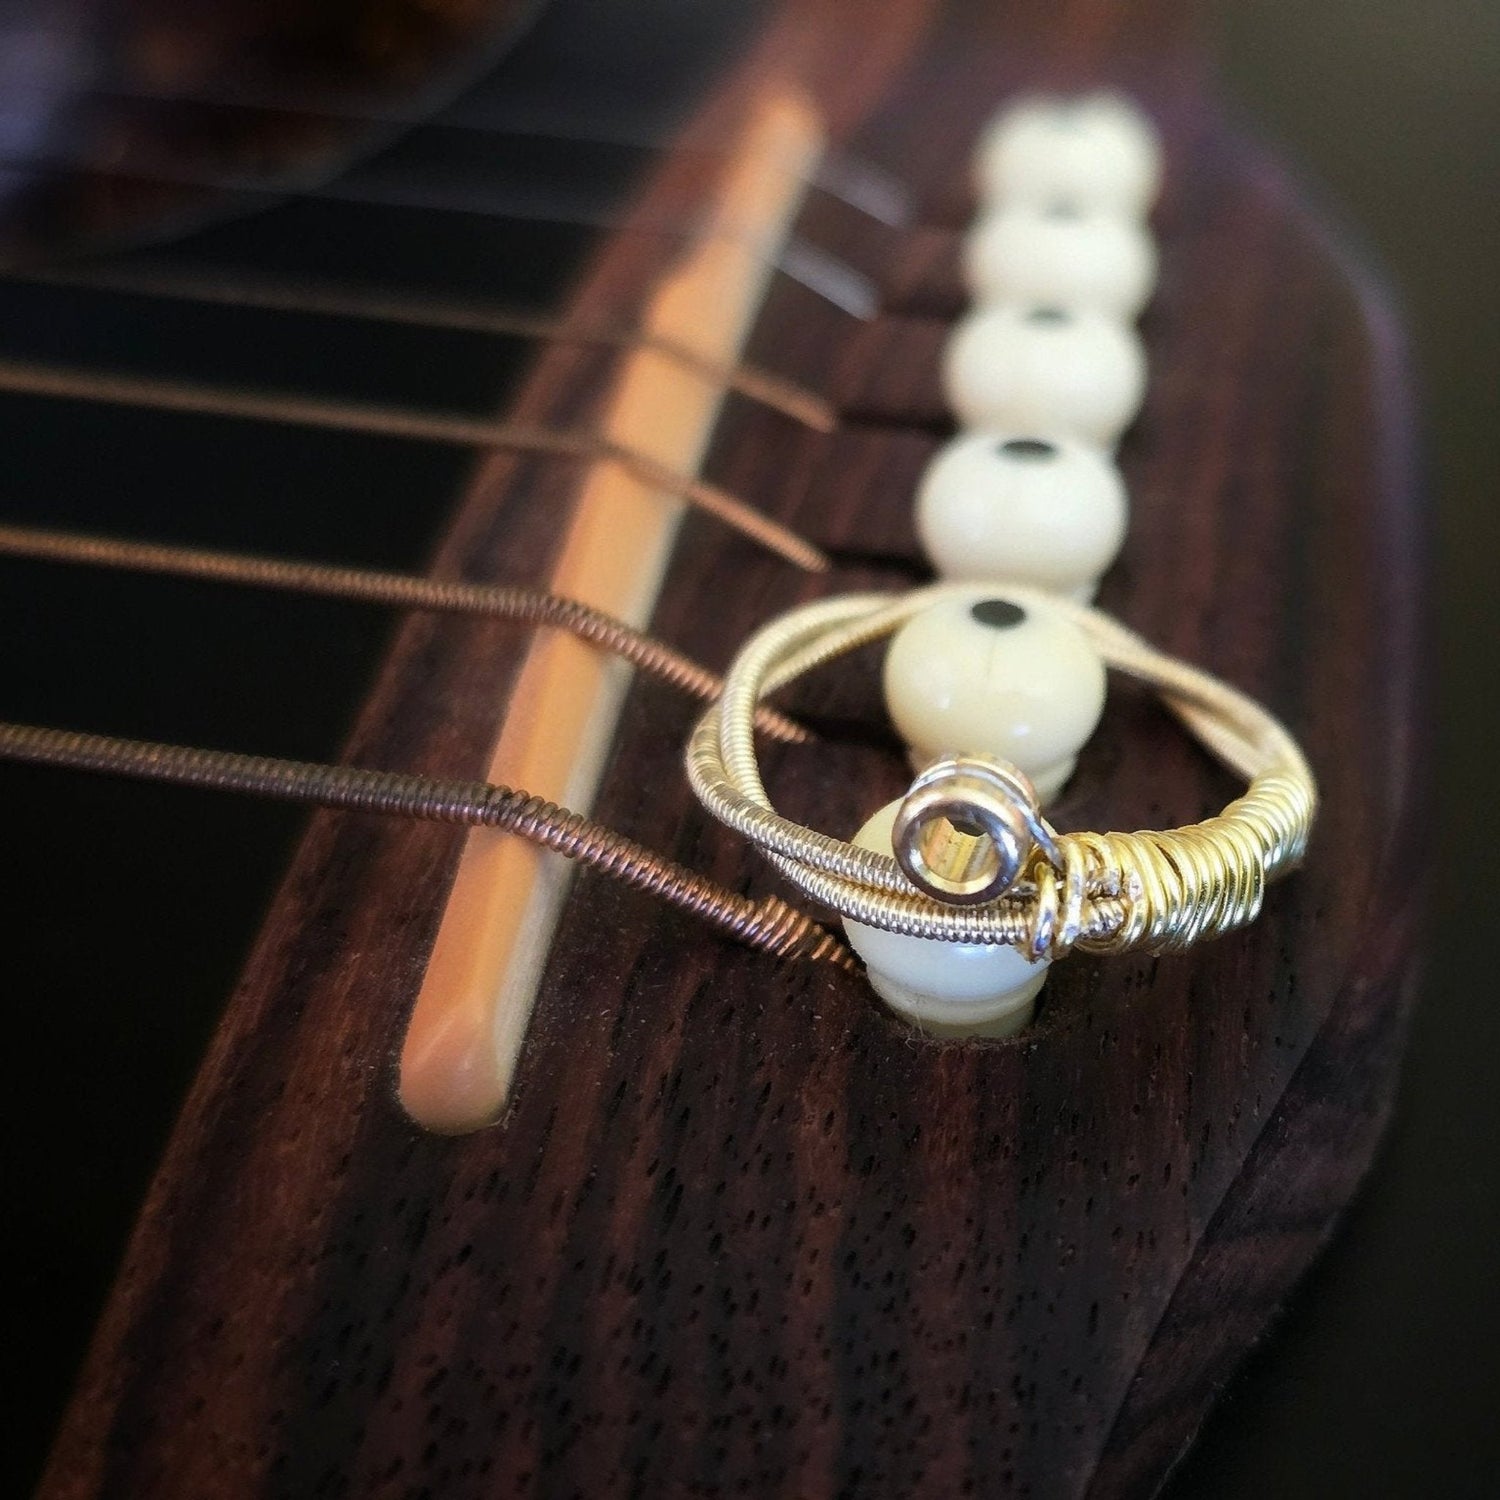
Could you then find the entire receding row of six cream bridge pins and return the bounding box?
[845,93,1161,1037]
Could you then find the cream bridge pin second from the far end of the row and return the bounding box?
[963,201,1157,321]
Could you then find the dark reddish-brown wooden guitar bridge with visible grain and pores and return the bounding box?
[42,5,1421,1500]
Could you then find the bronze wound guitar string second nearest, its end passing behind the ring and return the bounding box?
[0,524,810,744]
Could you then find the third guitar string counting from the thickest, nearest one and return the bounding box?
[0,359,830,573]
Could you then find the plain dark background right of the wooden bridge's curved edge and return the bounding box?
[1169,0,1500,1500]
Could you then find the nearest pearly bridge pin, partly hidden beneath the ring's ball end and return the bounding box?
[845,798,1049,1037]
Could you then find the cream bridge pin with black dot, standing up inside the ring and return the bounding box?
[884,590,1104,803]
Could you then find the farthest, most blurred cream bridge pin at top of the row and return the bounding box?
[974,93,1161,219]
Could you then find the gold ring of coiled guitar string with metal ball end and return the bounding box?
[687,584,1317,960]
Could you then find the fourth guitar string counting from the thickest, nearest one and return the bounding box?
[5,261,839,432]
